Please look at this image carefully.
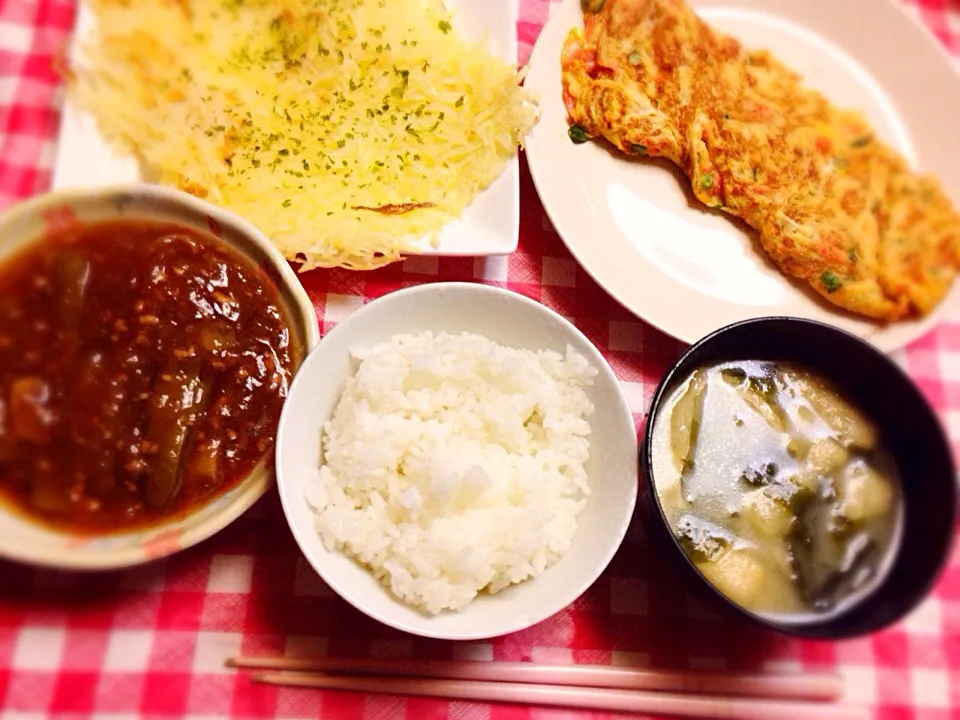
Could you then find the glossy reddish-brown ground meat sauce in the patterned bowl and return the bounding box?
[0,220,299,533]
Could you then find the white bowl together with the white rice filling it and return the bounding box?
[277,283,638,640]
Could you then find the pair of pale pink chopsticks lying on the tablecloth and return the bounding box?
[227,657,865,720]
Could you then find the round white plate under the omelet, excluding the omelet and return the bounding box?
[526,0,960,352]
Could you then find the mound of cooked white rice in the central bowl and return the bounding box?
[306,333,597,614]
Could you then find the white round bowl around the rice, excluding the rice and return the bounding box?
[277,283,639,640]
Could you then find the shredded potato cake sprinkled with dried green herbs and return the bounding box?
[70,0,537,270]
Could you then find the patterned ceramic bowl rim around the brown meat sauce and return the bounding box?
[0,184,320,570]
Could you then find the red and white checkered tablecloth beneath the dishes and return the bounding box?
[0,0,960,720]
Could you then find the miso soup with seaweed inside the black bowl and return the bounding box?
[651,361,902,621]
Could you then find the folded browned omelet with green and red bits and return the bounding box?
[561,0,960,321]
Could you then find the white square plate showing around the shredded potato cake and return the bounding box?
[53,0,520,256]
